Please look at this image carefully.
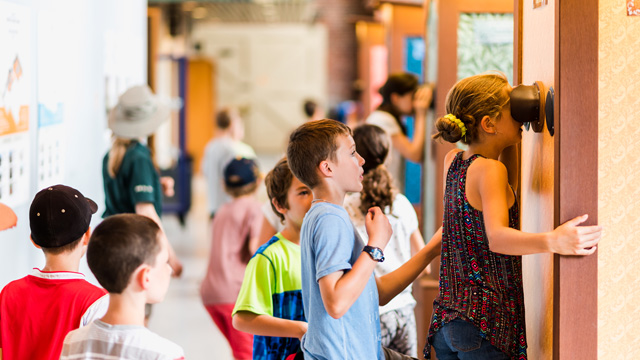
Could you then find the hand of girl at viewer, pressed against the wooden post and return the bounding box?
[550,214,602,255]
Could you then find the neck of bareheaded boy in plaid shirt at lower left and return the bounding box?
[100,290,146,326]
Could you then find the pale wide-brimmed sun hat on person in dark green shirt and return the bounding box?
[109,85,170,139]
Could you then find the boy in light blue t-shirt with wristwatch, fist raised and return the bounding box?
[287,120,440,360]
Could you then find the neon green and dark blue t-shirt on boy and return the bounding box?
[233,233,306,360]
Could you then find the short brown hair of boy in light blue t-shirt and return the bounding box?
[287,119,351,189]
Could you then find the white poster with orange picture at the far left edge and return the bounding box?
[0,1,32,207]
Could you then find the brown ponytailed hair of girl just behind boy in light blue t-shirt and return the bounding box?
[353,124,397,214]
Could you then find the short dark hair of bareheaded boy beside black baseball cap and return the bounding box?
[87,214,160,294]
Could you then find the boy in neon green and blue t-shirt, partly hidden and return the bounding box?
[233,158,312,360]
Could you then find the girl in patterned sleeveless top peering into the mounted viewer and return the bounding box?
[424,73,602,360]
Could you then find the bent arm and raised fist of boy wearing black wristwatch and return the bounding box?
[318,207,392,319]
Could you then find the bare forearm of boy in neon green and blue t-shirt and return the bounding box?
[233,311,307,339]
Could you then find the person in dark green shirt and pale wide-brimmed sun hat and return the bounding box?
[102,85,182,276]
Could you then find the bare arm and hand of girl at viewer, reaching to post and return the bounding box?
[478,160,602,255]
